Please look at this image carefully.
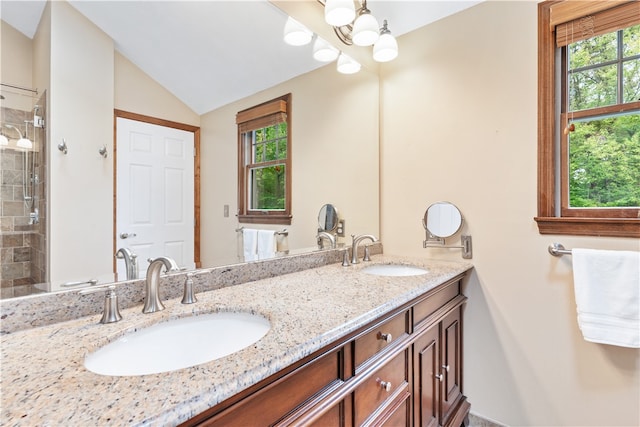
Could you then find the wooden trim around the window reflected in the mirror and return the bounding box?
[236,93,293,225]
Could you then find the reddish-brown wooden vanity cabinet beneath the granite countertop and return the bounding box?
[183,275,471,427]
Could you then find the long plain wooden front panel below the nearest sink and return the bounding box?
[200,351,340,427]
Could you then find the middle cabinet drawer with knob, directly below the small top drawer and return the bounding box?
[354,350,409,425]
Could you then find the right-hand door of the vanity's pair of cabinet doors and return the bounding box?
[441,308,462,425]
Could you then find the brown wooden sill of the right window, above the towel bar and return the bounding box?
[534,217,640,237]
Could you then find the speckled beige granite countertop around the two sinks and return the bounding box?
[0,255,472,426]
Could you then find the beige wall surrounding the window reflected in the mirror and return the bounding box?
[201,64,379,266]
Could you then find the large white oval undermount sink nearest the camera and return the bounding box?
[84,312,271,376]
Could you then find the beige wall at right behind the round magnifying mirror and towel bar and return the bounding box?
[381,1,640,426]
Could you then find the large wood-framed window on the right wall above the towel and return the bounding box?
[535,1,640,237]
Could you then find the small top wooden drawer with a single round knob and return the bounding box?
[354,311,409,368]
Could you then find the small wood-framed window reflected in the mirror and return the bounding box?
[236,94,291,225]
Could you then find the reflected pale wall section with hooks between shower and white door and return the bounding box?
[47,2,114,289]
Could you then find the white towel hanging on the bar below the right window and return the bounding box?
[572,249,640,348]
